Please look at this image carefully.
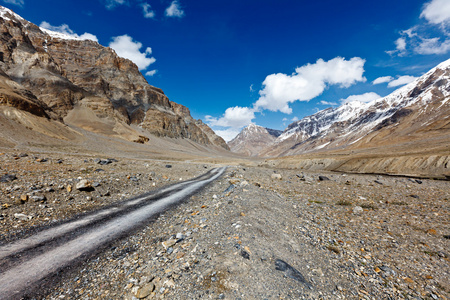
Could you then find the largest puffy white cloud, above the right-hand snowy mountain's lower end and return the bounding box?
[254,57,366,114]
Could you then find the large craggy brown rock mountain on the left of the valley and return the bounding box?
[0,6,228,149]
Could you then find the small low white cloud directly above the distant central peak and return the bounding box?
[205,106,255,129]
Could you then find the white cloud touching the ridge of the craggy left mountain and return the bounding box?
[109,34,156,70]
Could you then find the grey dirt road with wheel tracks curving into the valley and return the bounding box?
[0,168,225,299]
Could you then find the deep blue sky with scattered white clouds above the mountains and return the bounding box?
[0,0,450,141]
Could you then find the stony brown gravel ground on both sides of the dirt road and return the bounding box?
[0,153,450,299]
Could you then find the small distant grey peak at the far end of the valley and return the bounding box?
[228,124,282,156]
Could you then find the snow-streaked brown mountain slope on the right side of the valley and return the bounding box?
[232,59,450,156]
